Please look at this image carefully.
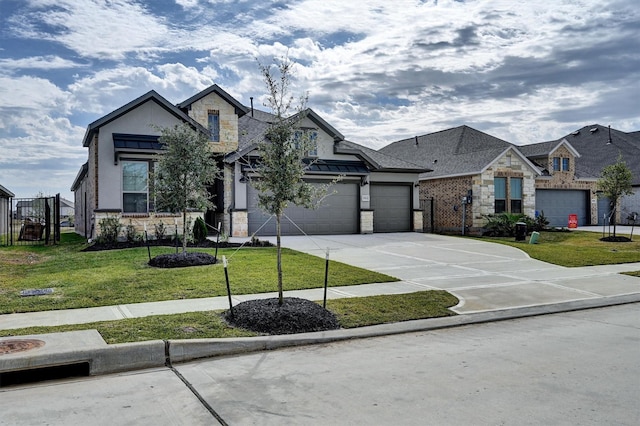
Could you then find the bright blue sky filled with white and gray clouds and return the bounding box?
[0,0,640,200]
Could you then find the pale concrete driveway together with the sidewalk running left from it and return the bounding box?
[0,233,640,330]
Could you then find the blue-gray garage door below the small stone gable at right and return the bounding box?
[536,189,591,227]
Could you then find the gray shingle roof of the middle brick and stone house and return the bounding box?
[379,126,515,179]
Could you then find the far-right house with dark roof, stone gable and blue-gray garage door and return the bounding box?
[518,124,640,226]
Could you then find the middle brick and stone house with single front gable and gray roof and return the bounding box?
[379,126,542,233]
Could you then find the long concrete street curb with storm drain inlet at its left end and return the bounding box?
[0,293,640,376]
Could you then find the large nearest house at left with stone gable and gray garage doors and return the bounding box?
[71,85,427,237]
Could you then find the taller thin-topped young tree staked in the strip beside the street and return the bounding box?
[250,57,326,305]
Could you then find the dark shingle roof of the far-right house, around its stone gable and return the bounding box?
[520,124,640,185]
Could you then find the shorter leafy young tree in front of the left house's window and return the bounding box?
[153,123,220,253]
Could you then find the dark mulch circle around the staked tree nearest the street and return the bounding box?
[228,297,340,334]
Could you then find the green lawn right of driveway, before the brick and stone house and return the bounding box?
[482,231,640,266]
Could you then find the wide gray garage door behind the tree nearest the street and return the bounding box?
[248,183,360,235]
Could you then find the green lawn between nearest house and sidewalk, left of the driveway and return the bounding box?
[0,233,397,313]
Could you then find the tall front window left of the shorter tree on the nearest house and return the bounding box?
[122,161,149,213]
